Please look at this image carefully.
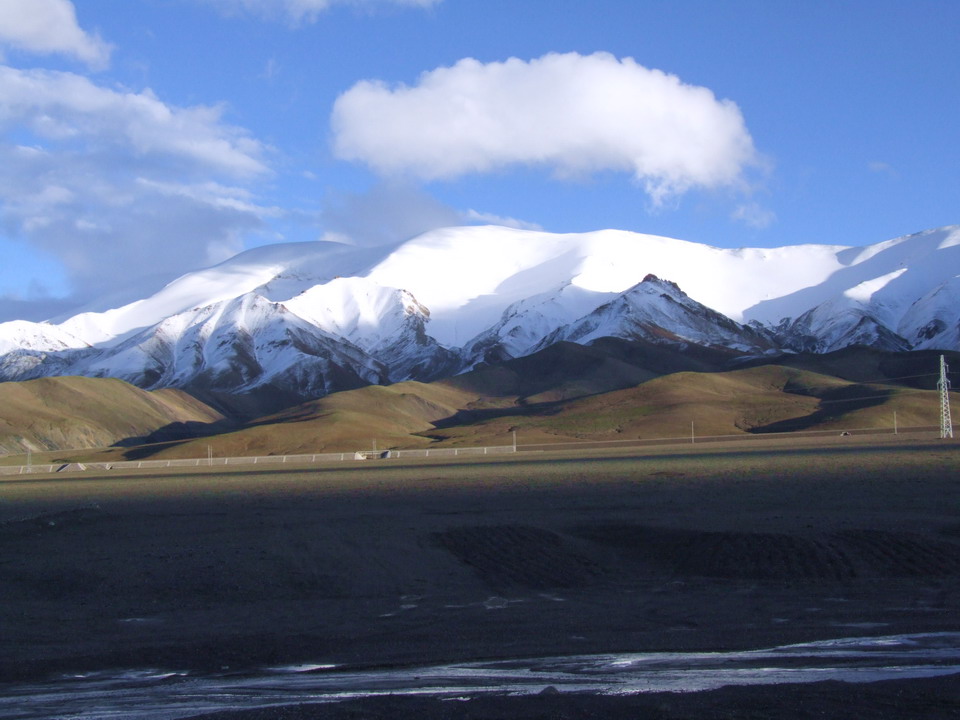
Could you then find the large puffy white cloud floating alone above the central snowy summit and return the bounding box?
[332,53,758,203]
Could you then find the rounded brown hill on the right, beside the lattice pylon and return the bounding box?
[412,365,939,445]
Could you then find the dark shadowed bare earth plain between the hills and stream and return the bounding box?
[0,439,960,720]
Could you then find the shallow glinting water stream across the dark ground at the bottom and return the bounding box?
[0,633,960,720]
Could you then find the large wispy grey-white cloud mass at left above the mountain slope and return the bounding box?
[0,67,275,320]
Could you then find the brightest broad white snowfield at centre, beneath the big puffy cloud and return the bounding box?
[369,227,846,345]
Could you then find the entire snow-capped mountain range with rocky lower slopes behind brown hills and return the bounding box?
[0,226,960,416]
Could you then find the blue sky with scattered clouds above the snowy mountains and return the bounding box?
[0,0,960,321]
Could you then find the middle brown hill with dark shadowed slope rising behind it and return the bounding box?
[118,338,744,458]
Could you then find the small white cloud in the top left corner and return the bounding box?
[0,0,111,69]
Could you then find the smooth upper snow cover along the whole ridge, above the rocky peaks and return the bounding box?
[11,226,960,347]
